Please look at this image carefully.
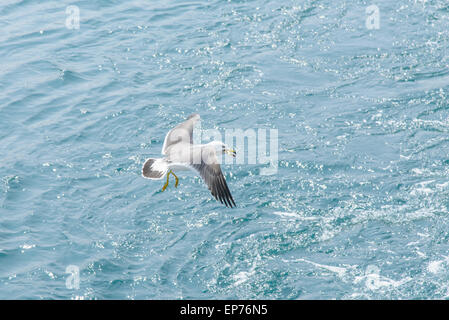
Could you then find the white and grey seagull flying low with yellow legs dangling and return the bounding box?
[142,113,236,208]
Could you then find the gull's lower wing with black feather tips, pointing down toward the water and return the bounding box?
[191,146,235,208]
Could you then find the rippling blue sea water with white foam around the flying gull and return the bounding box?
[0,0,449,299]
